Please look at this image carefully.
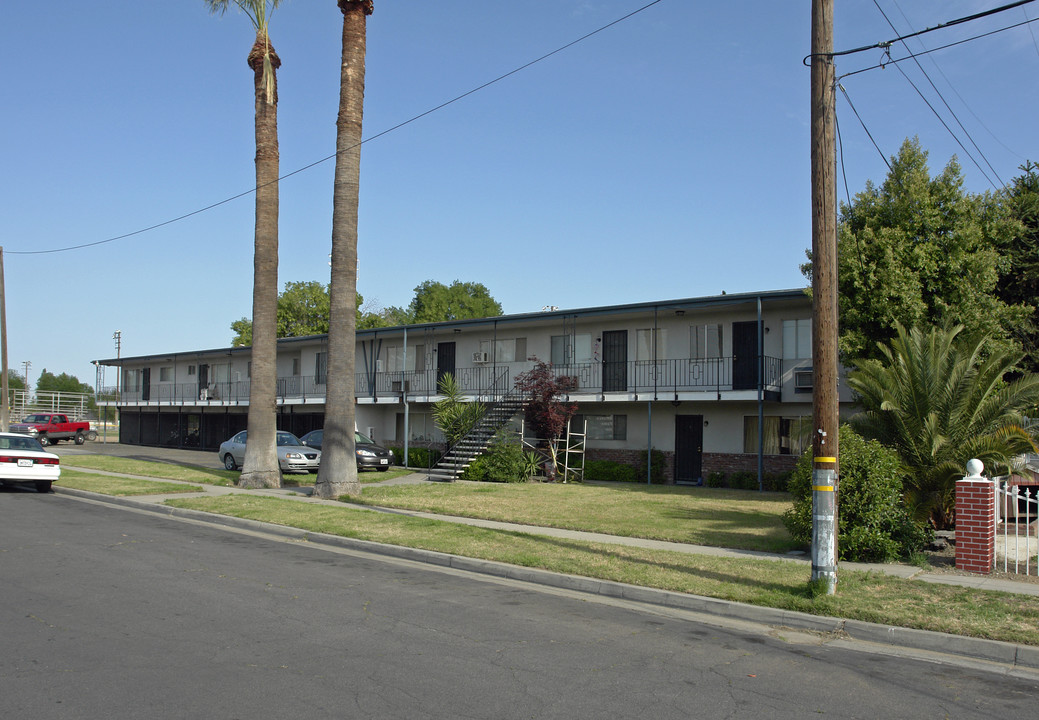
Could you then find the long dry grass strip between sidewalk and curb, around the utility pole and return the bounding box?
[167,495,1039,645]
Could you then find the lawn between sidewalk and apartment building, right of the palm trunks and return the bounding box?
[359,482,797,553]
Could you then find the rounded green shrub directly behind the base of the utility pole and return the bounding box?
[783,426,931,562]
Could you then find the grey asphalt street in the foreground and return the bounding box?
[0,490,1039,720]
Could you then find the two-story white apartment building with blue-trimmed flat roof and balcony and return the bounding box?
[99,290,851,483]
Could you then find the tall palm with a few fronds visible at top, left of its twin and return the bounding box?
[205,0,282,487]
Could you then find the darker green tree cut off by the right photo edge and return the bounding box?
[996,162,1039,372]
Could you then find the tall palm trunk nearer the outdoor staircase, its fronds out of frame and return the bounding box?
[314,0,375,498]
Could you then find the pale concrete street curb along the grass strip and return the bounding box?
[54,486,1039,669]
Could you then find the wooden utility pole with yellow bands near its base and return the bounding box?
[811,0,838,595]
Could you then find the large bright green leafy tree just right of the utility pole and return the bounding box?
[802,139,1032,362]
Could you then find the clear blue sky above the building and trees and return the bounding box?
[0,0,1039,385]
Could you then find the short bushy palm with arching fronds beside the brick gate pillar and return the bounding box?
[848,325,1039,529]
